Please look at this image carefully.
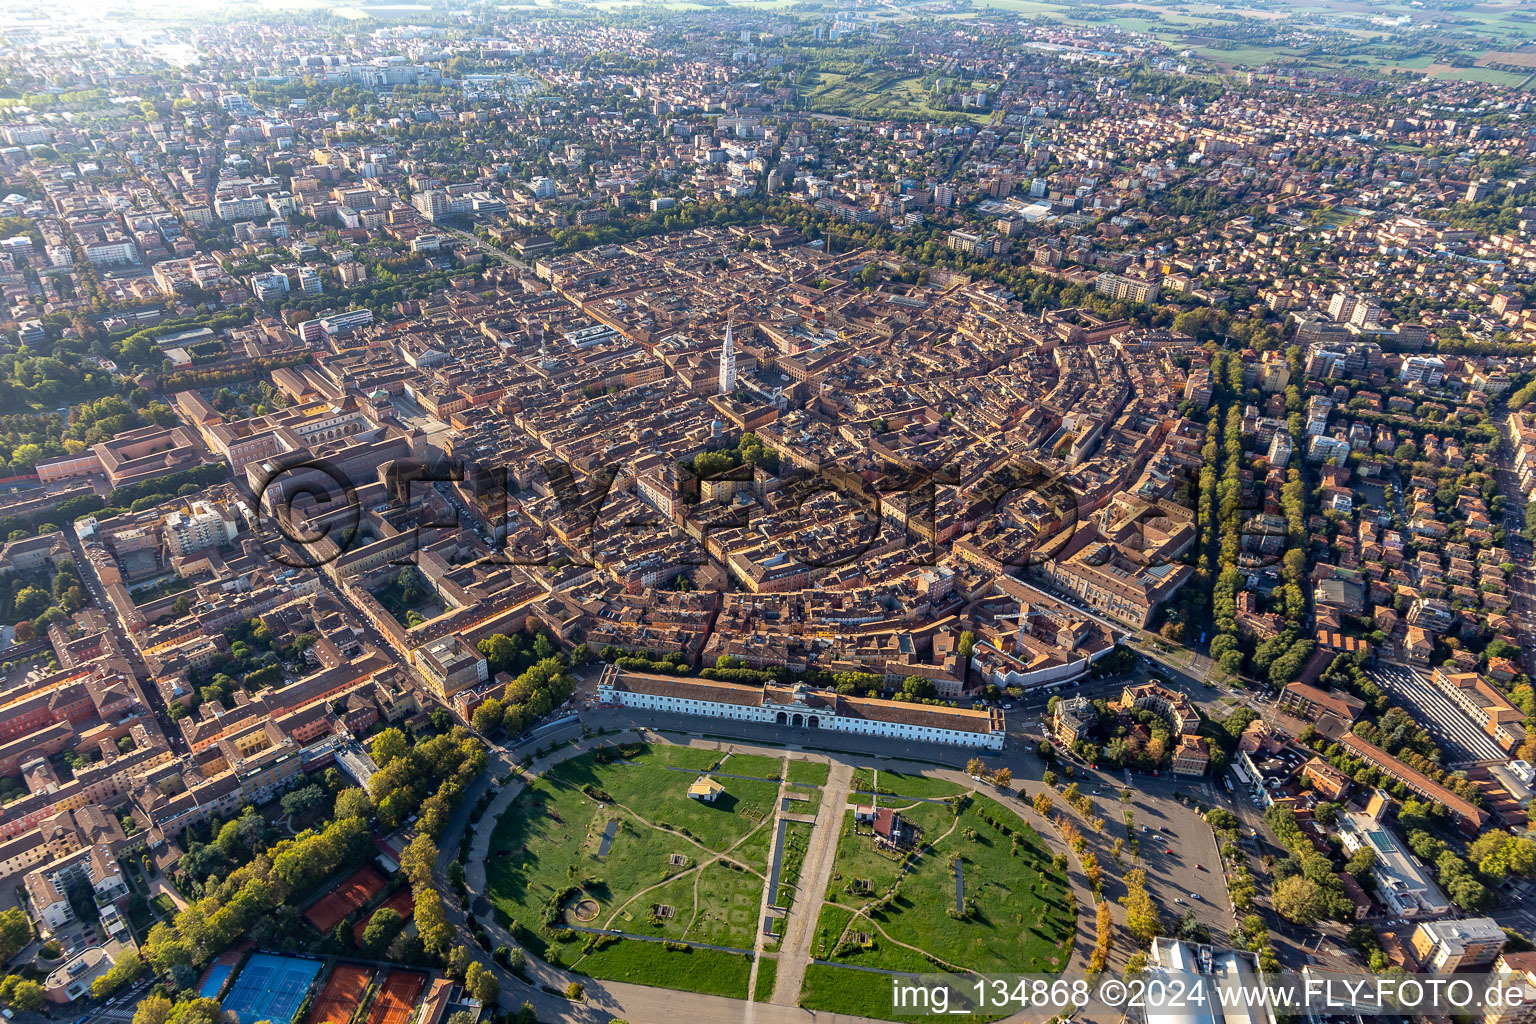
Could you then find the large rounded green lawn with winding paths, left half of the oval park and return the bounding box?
[485,746,777,982]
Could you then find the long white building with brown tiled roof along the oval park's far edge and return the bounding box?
[598,666,1006,751]
